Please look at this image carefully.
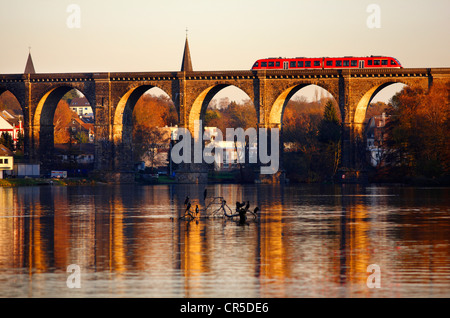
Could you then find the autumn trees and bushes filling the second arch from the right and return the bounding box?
[283,98,342,183]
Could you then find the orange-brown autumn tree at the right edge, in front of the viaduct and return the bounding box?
[386,83,450,178]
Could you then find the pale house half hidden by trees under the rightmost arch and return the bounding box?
[365,113,389,167]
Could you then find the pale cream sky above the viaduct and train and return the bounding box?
[0,0,450,101]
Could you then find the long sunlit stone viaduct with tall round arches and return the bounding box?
[0,41,450,180]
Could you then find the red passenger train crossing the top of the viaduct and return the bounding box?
[252,56,402,70]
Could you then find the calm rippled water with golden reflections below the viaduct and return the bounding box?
[0,185,450,298]
